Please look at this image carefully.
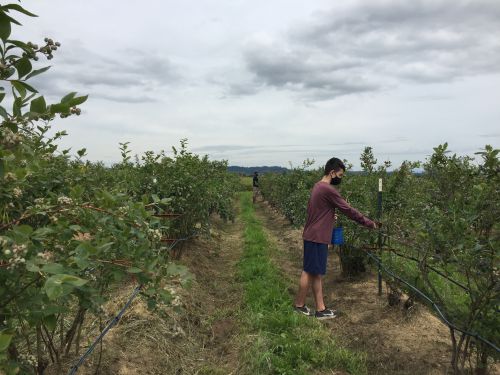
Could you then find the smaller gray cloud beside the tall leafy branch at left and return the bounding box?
[28,41,181,103]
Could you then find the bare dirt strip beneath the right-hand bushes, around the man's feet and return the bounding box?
[257,202,458,375]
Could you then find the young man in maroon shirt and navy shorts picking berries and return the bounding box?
[295,158,380,319]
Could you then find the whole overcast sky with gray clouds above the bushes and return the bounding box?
[13,0,500,166]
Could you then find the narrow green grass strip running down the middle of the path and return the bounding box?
[238,192,367,374]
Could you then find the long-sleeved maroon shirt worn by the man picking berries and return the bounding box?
[302,181,375,244]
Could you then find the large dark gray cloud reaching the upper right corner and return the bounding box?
[240,0,500,100]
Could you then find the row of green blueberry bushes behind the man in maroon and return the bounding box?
[261,144,500,373]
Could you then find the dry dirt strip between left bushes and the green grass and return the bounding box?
[57,213,245,375]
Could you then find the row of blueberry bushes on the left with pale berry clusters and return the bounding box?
[0,3,238,374]
